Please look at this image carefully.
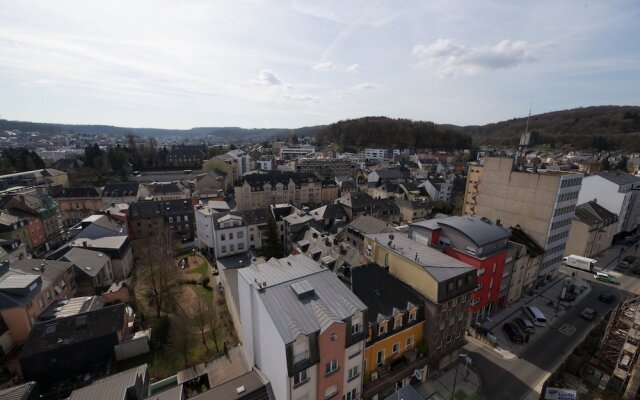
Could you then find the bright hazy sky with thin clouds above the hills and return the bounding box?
[0,0,640,128]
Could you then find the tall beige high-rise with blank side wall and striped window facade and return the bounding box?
[463,157,583,282]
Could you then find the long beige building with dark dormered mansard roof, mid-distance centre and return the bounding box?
[234,171,322,210]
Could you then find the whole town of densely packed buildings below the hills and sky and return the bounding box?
[0,121,640,400]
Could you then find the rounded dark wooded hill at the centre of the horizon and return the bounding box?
[317,117,472,150]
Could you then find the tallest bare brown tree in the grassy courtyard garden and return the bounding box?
[137,230,178,318]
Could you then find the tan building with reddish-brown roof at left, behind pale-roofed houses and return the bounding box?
[52,187,103,227]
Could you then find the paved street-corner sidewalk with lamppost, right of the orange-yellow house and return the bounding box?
[416,358,482,400]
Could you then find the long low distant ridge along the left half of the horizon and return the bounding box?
[0,119,324,140]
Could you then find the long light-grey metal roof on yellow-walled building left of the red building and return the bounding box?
[367,233,474,282]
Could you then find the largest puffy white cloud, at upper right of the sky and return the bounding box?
[412,39,551,78]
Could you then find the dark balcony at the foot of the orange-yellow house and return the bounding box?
[362,349,427,399]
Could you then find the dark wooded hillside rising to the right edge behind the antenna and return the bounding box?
[461,106,640,151]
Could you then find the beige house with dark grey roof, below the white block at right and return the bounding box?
[564,202,618,258]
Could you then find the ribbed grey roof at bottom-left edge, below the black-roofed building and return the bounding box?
[69,364,147,400]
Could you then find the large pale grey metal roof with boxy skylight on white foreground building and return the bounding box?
[240,255,367,343]
